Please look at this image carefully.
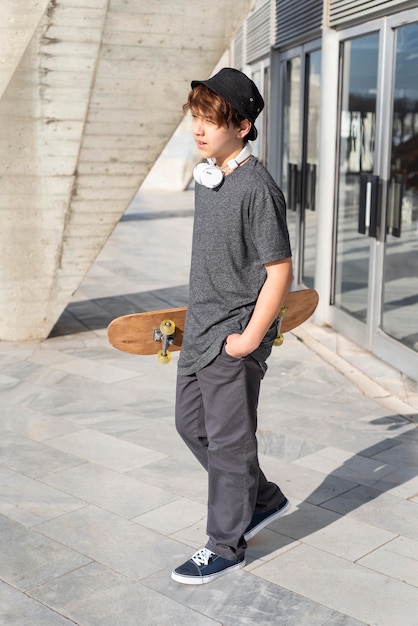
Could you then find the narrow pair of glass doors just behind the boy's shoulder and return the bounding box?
[279,42,321,287]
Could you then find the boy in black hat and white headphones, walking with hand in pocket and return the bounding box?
[172,68,292,584]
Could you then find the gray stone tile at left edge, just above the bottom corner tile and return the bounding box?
[0,516,90,590]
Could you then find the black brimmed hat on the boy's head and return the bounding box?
[192,67,264,141]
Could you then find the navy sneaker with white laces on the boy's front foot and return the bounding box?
[171,548,245,585]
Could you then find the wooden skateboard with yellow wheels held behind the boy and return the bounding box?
[107,289,319,363]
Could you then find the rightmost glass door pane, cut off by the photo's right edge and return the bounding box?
[382,22,418,356]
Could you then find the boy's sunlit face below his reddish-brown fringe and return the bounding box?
[191,111,251,167]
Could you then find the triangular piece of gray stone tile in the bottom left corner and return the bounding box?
[0,581,74,626]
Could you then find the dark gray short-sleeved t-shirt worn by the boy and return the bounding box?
[178,156,291,376]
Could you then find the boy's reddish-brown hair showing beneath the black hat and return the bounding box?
[183,84,246,128]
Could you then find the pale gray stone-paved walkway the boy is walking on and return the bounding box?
[0,192,418,626]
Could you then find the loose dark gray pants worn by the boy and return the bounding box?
[176,350,284,559]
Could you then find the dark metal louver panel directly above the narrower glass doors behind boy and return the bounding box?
[274,0,323,48]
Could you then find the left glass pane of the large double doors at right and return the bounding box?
[334,33,379,322]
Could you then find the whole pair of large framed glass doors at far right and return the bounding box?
[332,12,418,377]
